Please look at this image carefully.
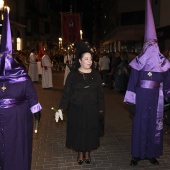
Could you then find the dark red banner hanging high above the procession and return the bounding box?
[61,13,80,43]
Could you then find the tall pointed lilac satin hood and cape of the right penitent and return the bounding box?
[130,0,170,72]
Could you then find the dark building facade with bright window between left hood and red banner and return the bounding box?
[4,0,63,50]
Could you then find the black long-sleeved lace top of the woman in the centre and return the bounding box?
[59,70,104,111]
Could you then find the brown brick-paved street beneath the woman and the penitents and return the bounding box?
[32,71,170,170]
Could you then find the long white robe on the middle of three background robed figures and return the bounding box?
[42,55,53,88]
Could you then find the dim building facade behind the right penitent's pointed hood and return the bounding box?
[94,0,170,52]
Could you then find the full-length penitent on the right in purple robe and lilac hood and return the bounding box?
[124,0,170,160]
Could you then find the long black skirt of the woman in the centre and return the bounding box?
[66,95,100,152]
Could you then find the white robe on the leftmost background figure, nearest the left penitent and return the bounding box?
[28,53,39,81]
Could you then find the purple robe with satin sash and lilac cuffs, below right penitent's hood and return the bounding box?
[124,68,170,159]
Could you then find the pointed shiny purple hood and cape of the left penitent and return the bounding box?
[0,7,29,83]
